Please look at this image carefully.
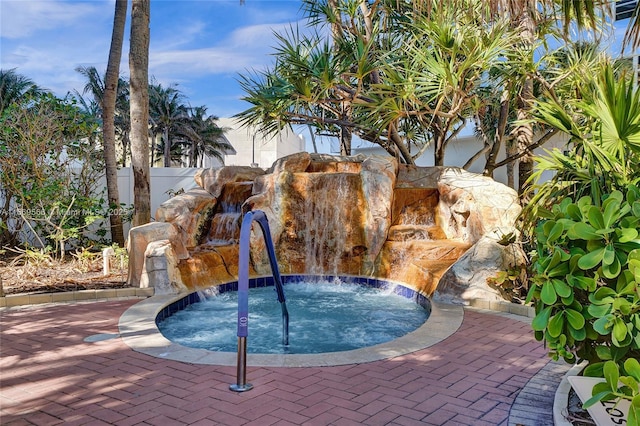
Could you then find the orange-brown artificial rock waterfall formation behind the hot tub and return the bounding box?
[129,153,523,303]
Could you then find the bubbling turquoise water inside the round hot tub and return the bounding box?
[158,282,429,354]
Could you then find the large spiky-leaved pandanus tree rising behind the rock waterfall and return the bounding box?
[238,1,519,165]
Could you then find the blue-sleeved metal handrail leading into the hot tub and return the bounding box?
[229,210,289,392]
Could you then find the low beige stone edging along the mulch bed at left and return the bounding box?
[0,288,154,308]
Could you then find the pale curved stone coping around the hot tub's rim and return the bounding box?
[118,294,464,367]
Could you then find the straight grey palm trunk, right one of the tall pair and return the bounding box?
[129,0,151,226]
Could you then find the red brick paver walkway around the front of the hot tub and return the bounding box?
[0,300,549,426]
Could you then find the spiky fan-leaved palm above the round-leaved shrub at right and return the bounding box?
[525,62,640,218]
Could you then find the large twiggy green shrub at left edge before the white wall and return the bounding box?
[0,94,102,257]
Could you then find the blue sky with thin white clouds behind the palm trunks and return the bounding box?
[0,0,302,117]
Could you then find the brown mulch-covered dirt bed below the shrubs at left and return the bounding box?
[0,253,128,295]
